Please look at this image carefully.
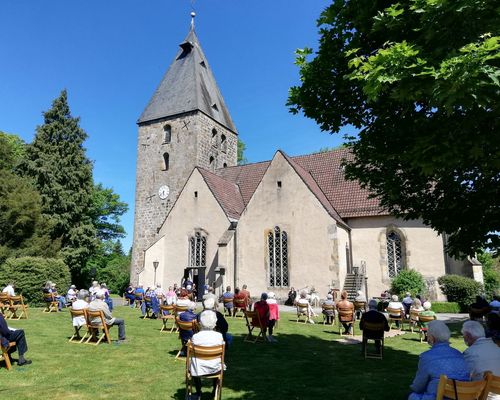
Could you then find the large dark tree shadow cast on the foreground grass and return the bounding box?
[173,332,420,400]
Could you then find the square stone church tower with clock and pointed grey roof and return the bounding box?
[131,13,238,283]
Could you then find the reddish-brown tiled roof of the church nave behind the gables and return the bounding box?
[215,149,389,223]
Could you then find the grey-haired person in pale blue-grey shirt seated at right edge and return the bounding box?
[462,321,500,381]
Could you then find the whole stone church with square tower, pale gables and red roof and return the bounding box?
[131,22,482,298]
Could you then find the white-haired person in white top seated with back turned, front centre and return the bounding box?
[189,310,225,399]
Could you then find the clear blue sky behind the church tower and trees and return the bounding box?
[0,0,352,249]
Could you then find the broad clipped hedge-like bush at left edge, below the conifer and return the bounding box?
[0,257,71,305]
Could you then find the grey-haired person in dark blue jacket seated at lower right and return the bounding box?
[408,321,470,400]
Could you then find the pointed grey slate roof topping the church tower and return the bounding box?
[138,26,236,133]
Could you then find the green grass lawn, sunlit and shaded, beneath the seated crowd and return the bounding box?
[0,307,465,400]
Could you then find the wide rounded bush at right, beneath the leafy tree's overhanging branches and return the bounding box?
[438,275,483,312]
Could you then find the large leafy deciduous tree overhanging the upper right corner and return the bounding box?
[288,0,500,256]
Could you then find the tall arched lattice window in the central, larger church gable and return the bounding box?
[267,226,288,287]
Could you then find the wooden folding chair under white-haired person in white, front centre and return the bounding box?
[186,341,225,400]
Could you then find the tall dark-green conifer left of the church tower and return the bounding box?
[19,90,97,274]
